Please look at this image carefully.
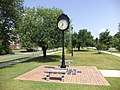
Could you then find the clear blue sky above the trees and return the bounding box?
[24,0,120,38]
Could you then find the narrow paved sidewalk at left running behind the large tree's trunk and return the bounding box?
[0,51,61,68]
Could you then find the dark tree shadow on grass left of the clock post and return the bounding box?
[22,55,61,63]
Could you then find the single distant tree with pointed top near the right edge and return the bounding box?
[99,29,112,49]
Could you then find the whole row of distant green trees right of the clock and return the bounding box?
[72,23,120,51]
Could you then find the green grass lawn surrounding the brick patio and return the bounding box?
[0,52,120,90]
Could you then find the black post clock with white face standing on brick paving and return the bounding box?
[57,14,70,68]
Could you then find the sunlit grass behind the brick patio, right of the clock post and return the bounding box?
[66,51,120,70]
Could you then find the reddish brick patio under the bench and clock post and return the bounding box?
[15,66,110,85]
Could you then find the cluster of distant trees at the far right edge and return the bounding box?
[95,23,120,51]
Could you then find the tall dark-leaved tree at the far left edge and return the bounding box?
[0,0,23,53]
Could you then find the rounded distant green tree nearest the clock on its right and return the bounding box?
[72,29,94,50]
